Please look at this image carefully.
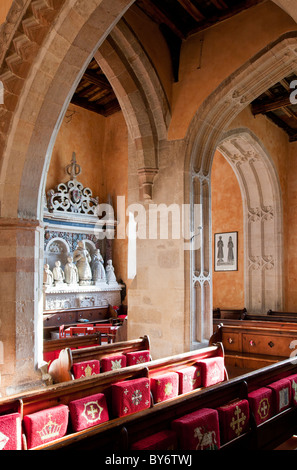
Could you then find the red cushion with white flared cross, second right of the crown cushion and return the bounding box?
[111,377,150,417]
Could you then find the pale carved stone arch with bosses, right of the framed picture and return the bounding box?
[218,129,283,314]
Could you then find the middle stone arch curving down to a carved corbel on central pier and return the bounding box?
[95,19,170,199]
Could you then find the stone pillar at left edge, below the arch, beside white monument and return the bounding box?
[0,218,43,397]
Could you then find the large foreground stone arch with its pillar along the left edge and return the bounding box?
[0,0,166,395]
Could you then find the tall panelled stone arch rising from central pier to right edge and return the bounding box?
[184,32,297,347]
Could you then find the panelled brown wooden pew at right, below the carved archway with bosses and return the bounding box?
[210,319,297,376]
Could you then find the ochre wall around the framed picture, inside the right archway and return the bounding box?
[211,151,245,309]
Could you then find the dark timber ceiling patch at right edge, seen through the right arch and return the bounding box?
[251,75,297,142]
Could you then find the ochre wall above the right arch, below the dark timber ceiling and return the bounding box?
[168,2,296,139]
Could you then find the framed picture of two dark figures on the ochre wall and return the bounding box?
[214,232,238,271]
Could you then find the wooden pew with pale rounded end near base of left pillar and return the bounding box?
[49,335,150,383]
